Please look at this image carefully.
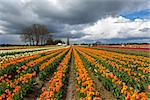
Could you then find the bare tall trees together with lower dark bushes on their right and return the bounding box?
[21,24,64,45]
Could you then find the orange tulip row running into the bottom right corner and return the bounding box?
[77,48,148,100]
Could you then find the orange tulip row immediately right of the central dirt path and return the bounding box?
[73,49,102,100]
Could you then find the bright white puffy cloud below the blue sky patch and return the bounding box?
[82,16,150,40]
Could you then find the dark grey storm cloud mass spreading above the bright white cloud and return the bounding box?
[0,0,149,43]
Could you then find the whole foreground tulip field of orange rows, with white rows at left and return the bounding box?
[0,46,150,100]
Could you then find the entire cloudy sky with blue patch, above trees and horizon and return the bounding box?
[0,0,150,44]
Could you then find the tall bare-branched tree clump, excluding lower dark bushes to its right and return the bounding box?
[21,24,50,45]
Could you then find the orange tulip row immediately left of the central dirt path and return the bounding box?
[39,48,72,100]
